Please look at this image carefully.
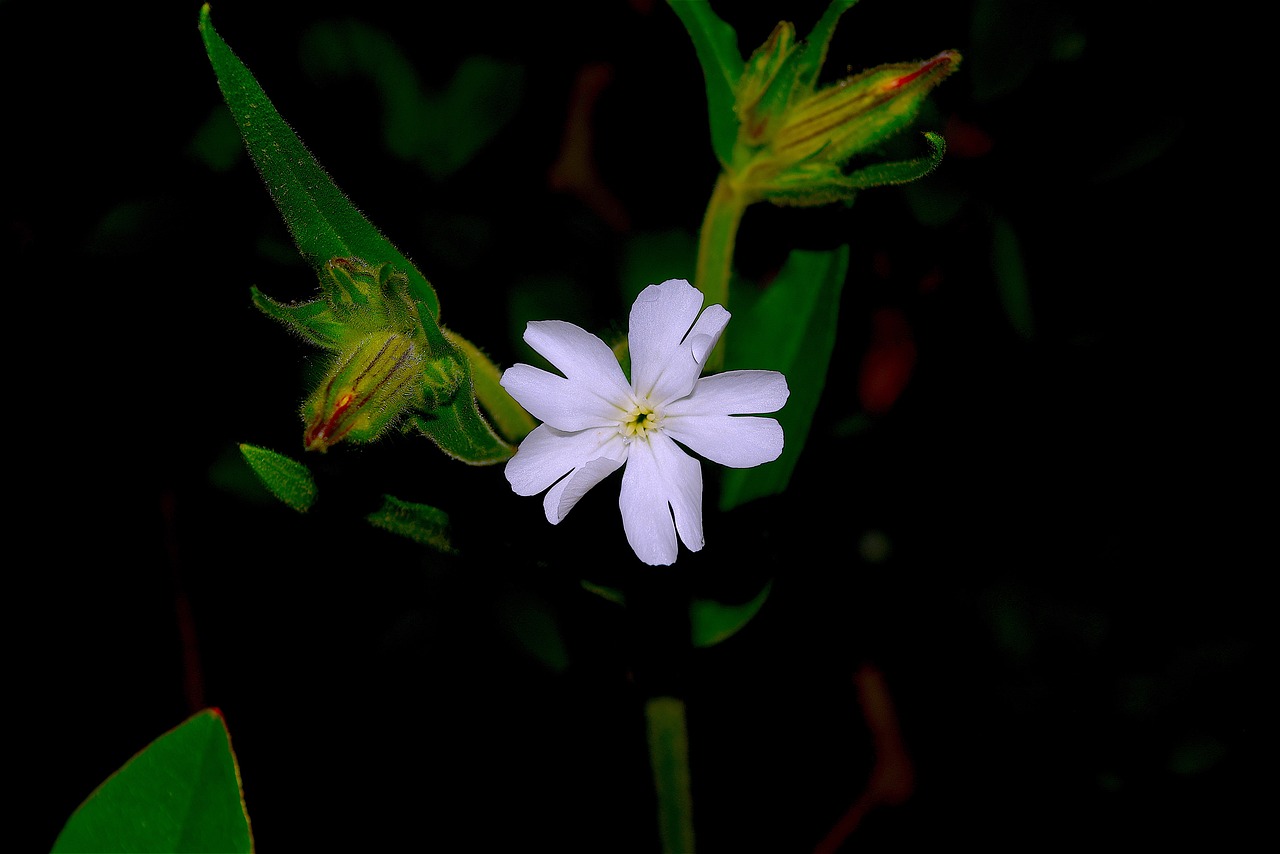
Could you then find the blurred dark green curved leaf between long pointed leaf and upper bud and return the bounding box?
[301,19,525,181]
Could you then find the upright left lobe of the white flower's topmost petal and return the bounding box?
[627,279,703,397]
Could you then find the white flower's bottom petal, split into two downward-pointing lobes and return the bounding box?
[618,434,705,566]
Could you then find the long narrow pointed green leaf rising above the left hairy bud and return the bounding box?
[200,3,440,323]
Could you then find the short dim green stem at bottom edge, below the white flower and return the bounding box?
[644,697,694,854]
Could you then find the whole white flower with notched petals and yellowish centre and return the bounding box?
[502,279,790,565]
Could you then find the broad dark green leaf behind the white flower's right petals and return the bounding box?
[719,246,849,511]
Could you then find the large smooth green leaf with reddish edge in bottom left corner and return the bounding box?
[52,709,253,854]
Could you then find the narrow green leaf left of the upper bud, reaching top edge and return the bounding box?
[667,0,744,165]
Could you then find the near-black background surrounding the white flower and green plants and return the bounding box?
[0,0,1267,851]
